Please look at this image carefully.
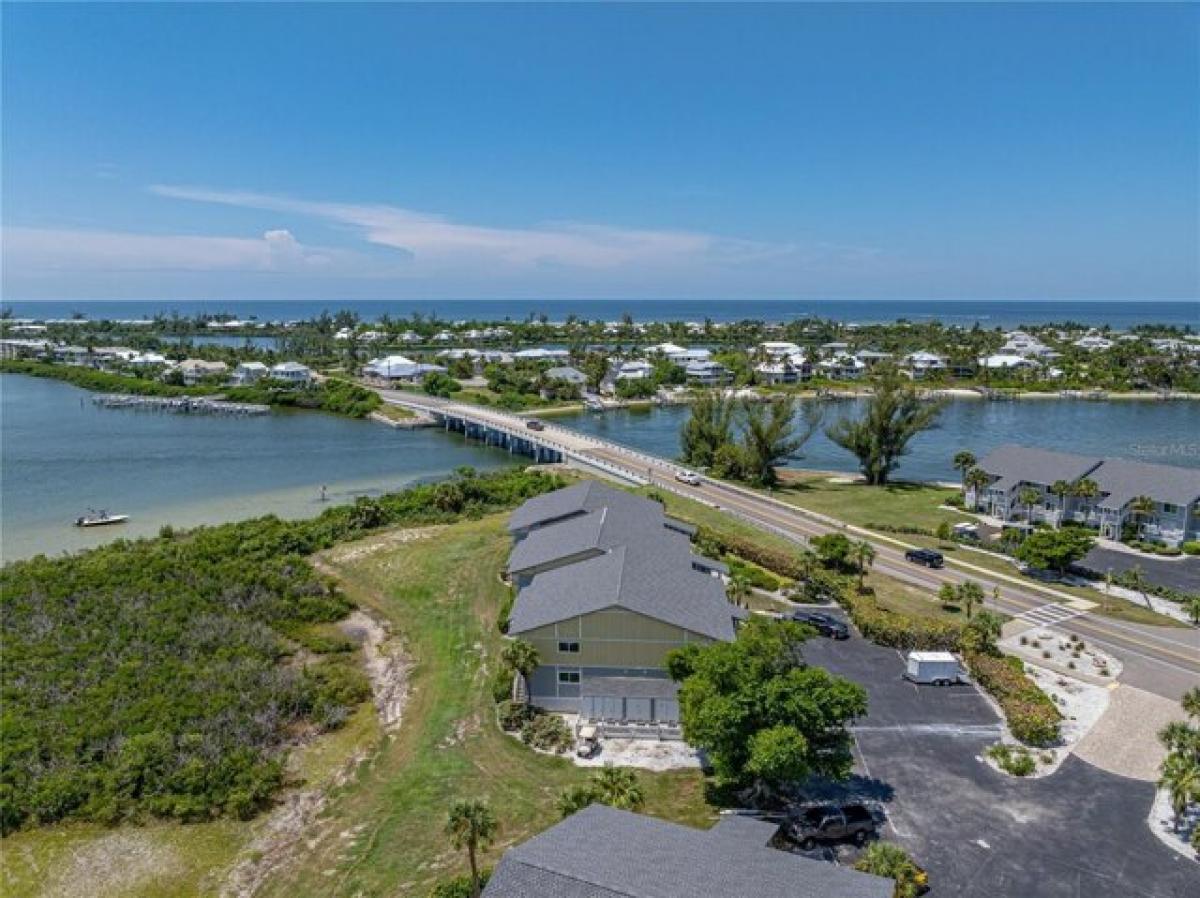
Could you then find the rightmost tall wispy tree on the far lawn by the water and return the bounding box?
[826,371,946,486]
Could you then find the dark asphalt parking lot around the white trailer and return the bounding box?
[805,619,1200,898]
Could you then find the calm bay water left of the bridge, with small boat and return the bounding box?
[0,375,515,559]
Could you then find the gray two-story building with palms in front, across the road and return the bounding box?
[966,445,1200,546]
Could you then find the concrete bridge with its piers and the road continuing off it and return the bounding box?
[379,390,1200,699]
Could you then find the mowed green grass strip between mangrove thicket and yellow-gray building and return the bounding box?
[265,516,714,898]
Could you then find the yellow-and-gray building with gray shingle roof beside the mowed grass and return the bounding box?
[508,481,742,725]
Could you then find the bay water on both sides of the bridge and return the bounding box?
[0,375,1200,559]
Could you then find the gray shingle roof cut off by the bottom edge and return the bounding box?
[484,804,893,898]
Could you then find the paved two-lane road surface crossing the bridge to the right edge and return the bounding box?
[380,390,1200,699]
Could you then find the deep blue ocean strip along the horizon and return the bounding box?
[4,299,1200,329]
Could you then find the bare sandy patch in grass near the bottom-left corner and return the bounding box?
[41,828,181,898]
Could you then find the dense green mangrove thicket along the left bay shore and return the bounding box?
[0,471,559,832]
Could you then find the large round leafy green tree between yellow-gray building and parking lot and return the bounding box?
[667,618,866,788]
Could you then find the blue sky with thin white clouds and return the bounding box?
[0,4,1200,300]
